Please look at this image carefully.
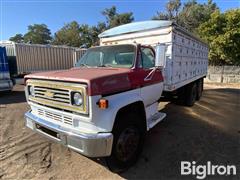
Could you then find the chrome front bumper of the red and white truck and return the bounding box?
[25,111,113,157]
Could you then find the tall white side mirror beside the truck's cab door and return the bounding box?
[155,44,166,68]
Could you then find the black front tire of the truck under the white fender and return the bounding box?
[105,112,145,173]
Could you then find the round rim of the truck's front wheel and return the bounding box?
[116,128,140,162]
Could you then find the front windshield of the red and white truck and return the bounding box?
[76,45,135,68]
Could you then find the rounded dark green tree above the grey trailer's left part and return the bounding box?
[23,24,52,44]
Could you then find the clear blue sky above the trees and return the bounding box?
[0,0,240,40]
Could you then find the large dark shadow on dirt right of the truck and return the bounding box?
[120,89,240,179]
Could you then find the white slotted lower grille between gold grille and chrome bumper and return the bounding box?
[37,109,73,125]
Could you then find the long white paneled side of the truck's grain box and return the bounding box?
[164,30,208,91]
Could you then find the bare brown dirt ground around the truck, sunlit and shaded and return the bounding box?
[0,84,240,180]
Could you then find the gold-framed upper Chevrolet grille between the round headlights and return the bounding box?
[27,79,88,114]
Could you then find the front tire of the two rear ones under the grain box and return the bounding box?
[185,82,197,107]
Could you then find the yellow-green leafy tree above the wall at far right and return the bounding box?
[198,9,240,65]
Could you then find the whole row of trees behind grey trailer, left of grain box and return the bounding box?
[9,6,134,47]
